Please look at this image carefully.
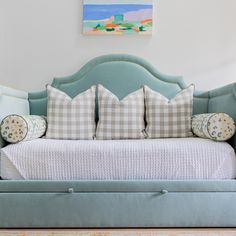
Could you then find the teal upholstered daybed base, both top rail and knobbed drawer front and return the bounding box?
[0,180,236,228]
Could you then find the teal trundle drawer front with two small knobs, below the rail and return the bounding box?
[0,192,236,228]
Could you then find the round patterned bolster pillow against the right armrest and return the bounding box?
[192,113,235,141]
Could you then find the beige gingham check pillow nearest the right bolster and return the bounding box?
[144,85,194,138]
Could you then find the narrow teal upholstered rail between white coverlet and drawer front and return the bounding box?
[0,180,236,193]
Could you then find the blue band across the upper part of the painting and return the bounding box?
[83,4,152,20]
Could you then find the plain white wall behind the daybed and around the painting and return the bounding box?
[0,0,236,90]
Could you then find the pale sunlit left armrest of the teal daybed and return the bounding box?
[0,85,29,148]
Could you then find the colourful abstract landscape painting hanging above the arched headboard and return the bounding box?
[83,0,153,35]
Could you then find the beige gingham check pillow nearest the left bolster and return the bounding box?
[46,85,96,139]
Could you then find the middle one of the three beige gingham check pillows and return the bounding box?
[96,85,145,139]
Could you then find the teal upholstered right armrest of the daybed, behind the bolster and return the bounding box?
[208,83,236,151]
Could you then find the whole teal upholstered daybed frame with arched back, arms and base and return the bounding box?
[0,55,236,228]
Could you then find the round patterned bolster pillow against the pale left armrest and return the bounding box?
[1,115,47,143]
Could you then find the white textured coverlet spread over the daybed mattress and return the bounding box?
[1,138,236,180]
